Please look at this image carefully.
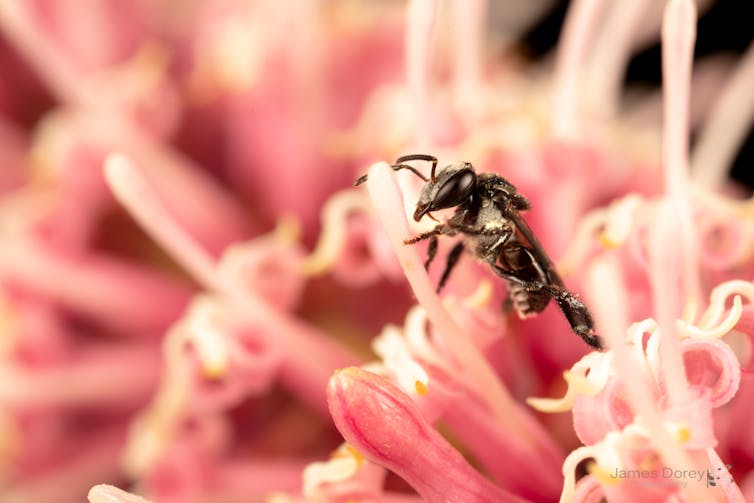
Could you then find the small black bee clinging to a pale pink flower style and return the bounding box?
[355,154,602,349]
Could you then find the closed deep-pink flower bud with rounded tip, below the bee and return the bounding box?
[327,367,521,503]
